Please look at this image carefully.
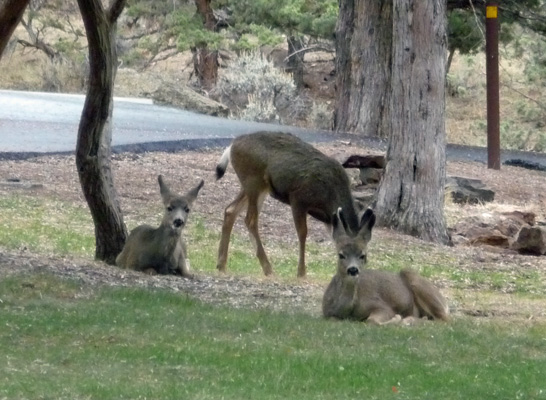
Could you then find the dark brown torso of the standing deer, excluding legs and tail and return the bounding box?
[231,132,358,231]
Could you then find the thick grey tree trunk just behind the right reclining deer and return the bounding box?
[376,0,450,244]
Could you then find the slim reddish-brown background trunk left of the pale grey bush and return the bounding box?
[192,0,218,91]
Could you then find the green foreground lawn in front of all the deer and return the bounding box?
[0,275,546,399]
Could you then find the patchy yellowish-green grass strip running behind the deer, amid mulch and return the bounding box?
[0,194,546,296]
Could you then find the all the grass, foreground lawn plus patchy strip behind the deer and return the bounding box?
[0,190,546,399]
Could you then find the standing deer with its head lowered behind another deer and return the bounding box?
[216,132,358,277]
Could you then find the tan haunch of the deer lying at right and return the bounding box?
[400,269,449,321]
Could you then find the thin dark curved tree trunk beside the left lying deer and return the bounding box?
[76,0,127,264]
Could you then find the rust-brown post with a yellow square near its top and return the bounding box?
[485,1,500,169]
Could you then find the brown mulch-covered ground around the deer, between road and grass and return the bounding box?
[0,142,546,320]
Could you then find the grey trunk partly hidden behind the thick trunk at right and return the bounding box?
[334,0,392,137]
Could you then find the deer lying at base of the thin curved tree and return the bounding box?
[116,175,204,277]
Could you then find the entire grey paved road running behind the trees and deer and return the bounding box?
[0,90,546,170]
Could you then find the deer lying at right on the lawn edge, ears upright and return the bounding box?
[322,209,449,325]
